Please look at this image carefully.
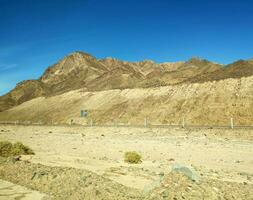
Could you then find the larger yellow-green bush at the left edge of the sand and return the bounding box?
[0,141,34,157]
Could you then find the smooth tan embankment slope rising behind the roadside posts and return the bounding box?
[0,76,253,126]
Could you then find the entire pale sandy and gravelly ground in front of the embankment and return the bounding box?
[0,125,253,199]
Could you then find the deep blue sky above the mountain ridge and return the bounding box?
[0,0,253,95]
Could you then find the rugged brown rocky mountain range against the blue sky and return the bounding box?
[0,52,253,112]
